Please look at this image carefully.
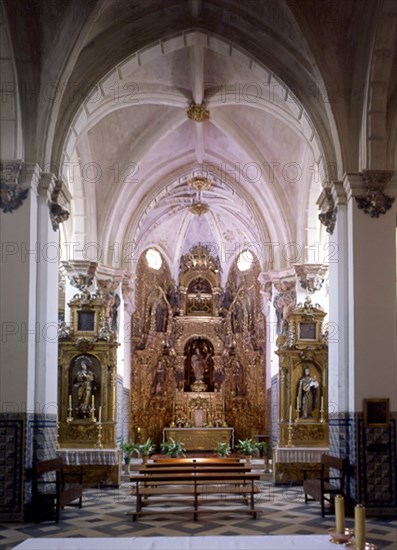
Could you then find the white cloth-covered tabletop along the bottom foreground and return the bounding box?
[14,535,335,550]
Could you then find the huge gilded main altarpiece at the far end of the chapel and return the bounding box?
[131,246,267,450]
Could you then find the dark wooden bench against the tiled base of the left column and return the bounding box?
[32,458,83,523]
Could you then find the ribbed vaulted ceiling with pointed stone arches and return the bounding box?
[5,0,395,280]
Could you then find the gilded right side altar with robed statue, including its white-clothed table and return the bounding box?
[274,297,328,483]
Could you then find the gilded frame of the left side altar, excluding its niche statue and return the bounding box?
[57,293,118,449]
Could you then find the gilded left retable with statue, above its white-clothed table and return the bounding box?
[58,286,118,449]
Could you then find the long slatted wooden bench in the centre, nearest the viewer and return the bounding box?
[130,468,260,521]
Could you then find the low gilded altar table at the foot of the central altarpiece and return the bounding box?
[163,428,234,451]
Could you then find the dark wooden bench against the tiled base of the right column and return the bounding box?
[303,454,347,517]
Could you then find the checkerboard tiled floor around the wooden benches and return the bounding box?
[0,481,397,550]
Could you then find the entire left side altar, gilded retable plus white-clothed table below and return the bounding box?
[57,289,118,485]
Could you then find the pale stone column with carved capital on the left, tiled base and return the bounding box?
[0,162,68,521]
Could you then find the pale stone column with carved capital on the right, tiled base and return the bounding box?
[329,171,397,501]
